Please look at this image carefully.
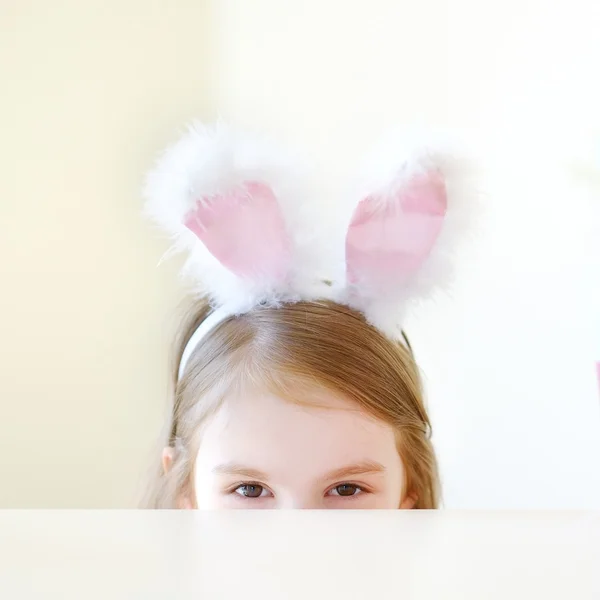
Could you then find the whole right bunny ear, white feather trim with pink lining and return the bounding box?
[345,131,474,339]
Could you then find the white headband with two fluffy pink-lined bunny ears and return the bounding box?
[144,123,472,377]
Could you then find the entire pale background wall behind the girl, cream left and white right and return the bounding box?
[0,0,600,507]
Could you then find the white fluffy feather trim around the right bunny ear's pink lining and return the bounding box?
[338,130,479,339]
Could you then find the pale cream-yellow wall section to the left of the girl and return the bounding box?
[0,0,216,507]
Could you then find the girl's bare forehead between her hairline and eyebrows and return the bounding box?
[197,391,400,477]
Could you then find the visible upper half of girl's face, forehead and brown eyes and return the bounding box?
[190,392,414,509]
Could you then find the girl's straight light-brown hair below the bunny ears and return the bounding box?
[143,301,439,509]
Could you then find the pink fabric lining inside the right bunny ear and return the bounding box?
[346,172,447,293]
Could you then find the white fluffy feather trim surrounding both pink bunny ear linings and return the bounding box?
[144,122,478,339]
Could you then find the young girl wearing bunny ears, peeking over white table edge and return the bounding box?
[144,124,474,509]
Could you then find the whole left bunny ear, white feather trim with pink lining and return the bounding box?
[144,123,322,314]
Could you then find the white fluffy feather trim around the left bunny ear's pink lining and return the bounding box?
[144,122,325,314]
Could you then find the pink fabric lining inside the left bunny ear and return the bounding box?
[185,181,291,280]
